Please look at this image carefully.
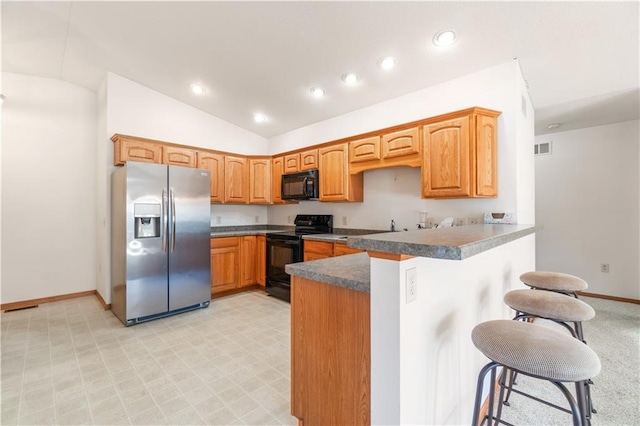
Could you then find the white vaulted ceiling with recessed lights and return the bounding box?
[1,1,640,137]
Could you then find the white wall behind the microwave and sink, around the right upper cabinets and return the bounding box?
[269,61,535,229]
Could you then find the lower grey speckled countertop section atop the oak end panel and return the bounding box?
[285,253,371,293]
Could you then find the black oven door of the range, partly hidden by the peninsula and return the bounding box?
[265,237,302,301]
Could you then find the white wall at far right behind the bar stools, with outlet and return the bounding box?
[535,120,640,300]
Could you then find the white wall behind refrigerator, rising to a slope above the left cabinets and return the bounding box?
[97,73,267,303]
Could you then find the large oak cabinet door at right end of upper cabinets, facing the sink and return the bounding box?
[422,116,472,198]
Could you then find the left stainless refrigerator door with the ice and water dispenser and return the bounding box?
[124,162,169,320]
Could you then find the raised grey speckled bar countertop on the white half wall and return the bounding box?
[347,224,535,260]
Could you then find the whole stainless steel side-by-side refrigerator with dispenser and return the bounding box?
[111,162,211,326]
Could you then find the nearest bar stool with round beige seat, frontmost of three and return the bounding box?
[471,320,600,426]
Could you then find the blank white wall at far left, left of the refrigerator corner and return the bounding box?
[0,73,97,303]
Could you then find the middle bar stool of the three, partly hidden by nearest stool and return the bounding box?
[503,290,597,419]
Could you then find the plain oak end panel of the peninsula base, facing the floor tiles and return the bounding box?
[291,275,371,426]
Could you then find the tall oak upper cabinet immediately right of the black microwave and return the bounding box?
[318,143,363,201]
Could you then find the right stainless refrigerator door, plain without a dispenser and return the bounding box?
[168,166,211,311]
